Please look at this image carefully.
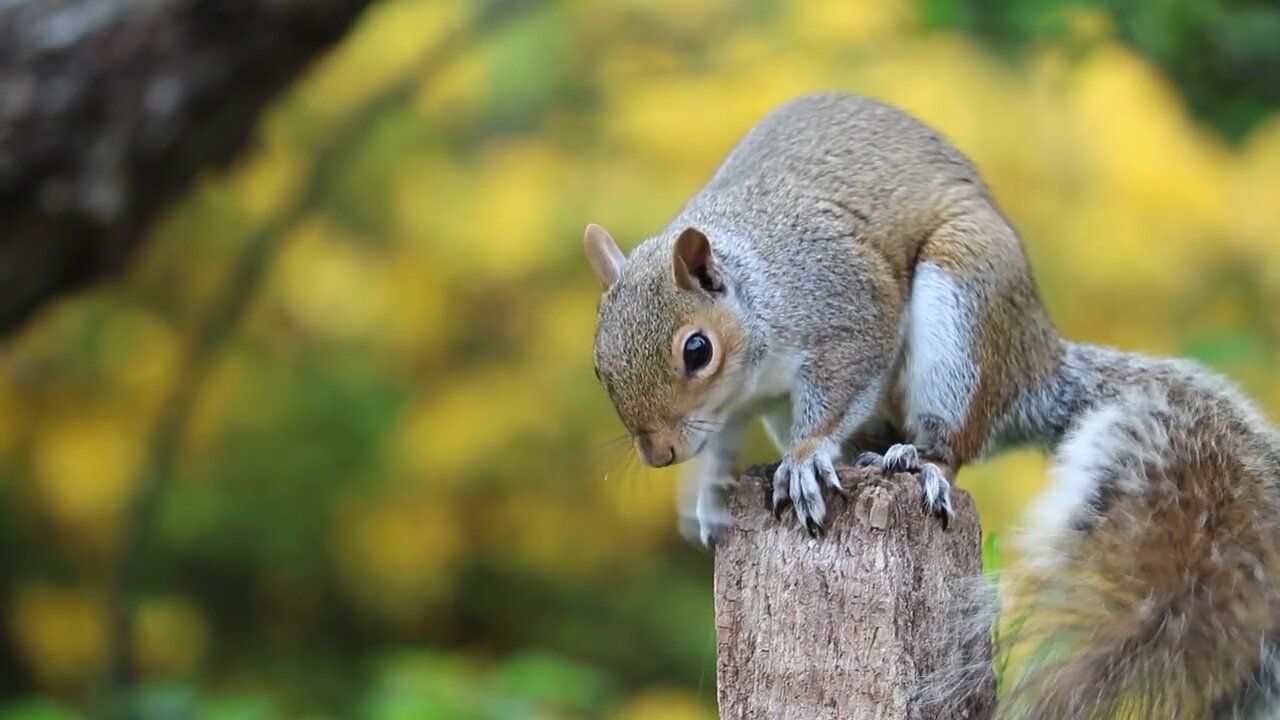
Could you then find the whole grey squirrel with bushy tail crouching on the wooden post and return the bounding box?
[584,92,1280,719]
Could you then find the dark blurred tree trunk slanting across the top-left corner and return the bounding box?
[0,0,370,336]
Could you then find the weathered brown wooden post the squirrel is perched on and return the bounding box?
[716,466,995,720]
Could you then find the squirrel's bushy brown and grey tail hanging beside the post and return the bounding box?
[997,395,1280,720]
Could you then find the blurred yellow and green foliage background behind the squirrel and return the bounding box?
[0,0,1280,720]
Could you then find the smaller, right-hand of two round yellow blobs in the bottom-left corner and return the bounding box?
[133,597,209,675]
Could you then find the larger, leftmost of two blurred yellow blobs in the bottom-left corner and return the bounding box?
[9,583,106,689]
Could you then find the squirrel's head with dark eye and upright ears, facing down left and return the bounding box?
[584,224,748,468]
